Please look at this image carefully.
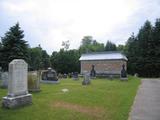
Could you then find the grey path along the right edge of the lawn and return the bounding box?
[129,79,160,120]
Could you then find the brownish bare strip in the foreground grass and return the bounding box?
[53,101,105,118]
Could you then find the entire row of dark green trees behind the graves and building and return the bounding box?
[0,19,160,77]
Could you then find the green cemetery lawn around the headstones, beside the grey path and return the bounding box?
[0,76,140,120]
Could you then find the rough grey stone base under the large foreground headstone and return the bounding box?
[2,94,32,108]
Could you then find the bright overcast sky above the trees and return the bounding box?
[0,0,160,54]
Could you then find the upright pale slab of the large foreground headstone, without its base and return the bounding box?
[8,59,28,96]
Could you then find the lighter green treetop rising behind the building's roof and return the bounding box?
[79,36,104,53]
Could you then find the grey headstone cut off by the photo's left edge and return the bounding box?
[1,72,8,88]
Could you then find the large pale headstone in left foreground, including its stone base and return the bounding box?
[2,59,32,108]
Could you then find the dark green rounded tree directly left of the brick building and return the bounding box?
[51,49,80,73]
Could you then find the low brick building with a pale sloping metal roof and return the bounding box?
[79,52,128,75]
